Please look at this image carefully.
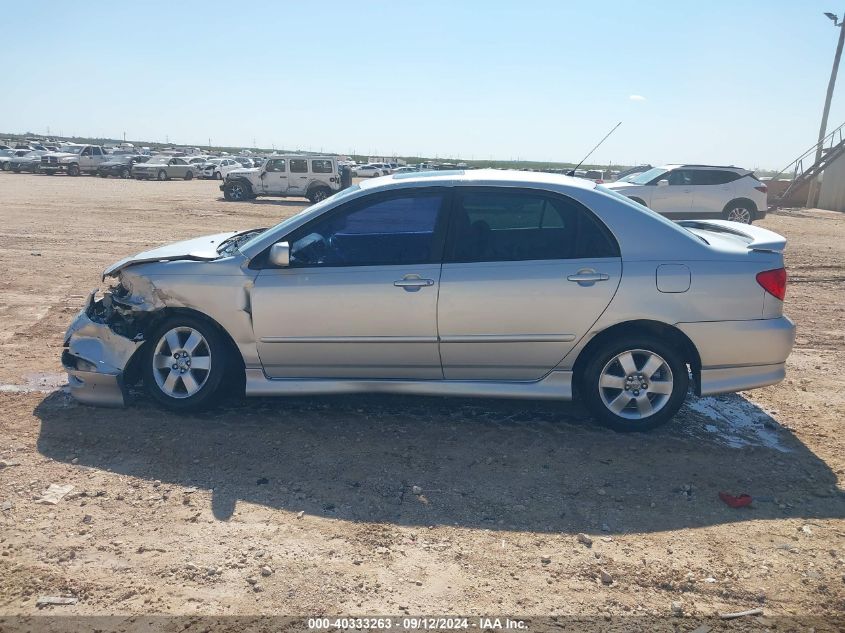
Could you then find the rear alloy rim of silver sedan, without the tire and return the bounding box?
[598,349,674,420]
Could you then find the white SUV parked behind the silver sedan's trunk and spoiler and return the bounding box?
[605,165,768,224]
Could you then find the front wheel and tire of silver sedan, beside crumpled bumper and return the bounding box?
[142,315,229,412]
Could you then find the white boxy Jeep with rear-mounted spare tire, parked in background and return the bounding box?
[220,154,340,202]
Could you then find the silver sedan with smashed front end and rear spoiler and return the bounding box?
[62,170,795,430]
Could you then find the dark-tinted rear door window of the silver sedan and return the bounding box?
[447,190,619,262]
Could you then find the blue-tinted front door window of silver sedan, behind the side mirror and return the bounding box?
[289,188,444,267]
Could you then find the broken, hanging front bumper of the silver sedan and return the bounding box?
[62,292,143,407]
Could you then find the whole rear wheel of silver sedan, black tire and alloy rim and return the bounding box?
[579,335,689,432]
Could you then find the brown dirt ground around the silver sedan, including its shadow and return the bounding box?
[0,172,845,631]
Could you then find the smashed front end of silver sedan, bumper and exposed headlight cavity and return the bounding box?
[62,284,157,407]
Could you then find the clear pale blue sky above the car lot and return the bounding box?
[0,0,845,169]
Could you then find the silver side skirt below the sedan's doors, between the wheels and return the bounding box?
[246,369,572,400]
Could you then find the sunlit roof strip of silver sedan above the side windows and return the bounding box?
[359,169,596,189]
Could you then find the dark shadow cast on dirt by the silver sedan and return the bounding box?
[29,392,845,533]
